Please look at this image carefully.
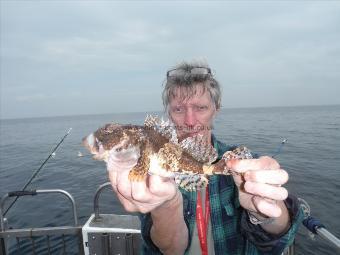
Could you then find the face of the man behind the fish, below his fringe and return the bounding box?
[169,85,216,140]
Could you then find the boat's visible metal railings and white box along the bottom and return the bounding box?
[0,182,340,255]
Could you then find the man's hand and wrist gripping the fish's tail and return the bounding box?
[227,156,289,233]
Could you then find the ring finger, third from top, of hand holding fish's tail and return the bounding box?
[244,181,288,200]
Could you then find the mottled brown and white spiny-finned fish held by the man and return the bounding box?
[83,116,252,191]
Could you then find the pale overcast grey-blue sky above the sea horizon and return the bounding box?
[0,1,340,118]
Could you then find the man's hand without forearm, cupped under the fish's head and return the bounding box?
[107,148,177,213]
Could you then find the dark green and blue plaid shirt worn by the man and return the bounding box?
[140,136,303,255]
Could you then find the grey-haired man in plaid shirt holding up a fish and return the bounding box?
[108,60,302,255]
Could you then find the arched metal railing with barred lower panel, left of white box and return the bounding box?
[0,189,84,255]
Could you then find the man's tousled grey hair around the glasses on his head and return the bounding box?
[162,61,221,113]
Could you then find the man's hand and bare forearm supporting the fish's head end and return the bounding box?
[107,149,188,255]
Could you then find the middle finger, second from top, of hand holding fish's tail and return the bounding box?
[243,169,288,185]
